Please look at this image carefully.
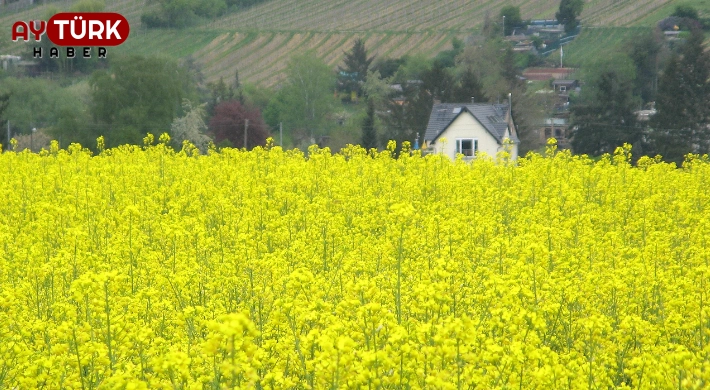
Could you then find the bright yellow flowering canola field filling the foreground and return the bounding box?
[0,139,710,389]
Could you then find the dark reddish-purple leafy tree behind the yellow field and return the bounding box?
[210,100,269,149]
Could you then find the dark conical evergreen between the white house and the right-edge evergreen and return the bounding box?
[571,71,643,156]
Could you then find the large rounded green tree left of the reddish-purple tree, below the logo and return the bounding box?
[90,55,186,146]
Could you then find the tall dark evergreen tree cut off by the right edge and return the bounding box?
[650,29,710,163]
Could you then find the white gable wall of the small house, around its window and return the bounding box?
[433,112,518,160]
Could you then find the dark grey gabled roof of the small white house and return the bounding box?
[424,103,518,144]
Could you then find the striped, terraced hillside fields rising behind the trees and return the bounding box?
[0,0,707,86]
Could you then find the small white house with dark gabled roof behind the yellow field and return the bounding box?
[424,103,520,160]
